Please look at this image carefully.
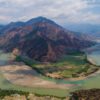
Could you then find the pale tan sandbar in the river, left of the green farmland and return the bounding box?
[0,64,73,89]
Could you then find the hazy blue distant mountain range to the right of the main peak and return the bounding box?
[64,24,100,39]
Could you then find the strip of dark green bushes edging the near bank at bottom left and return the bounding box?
[0,89,65,100]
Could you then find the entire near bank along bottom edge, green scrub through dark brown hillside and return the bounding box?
[0,89,100,100]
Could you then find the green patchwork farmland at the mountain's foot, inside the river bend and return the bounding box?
[16,52,99,78]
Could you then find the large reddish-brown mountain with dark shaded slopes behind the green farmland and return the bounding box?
[0,17,93,61]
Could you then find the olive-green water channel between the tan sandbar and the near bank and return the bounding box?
[0,73,69,97]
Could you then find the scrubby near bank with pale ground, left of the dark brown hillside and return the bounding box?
[0,89,66,100]
